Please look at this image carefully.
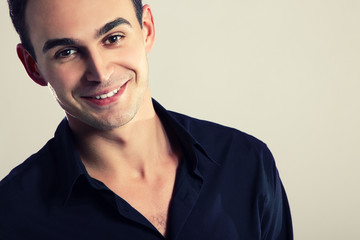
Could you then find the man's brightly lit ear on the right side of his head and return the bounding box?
[142,4,155,53]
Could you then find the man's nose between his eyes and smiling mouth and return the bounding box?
[86,50,113,82]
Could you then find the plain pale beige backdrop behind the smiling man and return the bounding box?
[0,0,360,240]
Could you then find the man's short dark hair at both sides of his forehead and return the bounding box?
[8,0,143,60]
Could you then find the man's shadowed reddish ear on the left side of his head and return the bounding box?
[16,44,47,86]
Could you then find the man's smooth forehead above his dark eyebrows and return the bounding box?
[25,0,136,44]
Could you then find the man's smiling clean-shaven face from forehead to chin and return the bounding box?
[26,0,153,129]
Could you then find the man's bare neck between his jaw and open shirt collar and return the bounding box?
[68,99,177,179]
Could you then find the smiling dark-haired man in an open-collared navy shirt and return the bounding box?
[0,0,292,239]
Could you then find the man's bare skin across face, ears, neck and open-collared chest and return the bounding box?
[17,0,179,235]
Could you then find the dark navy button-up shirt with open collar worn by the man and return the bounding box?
[0,101,292,240]
